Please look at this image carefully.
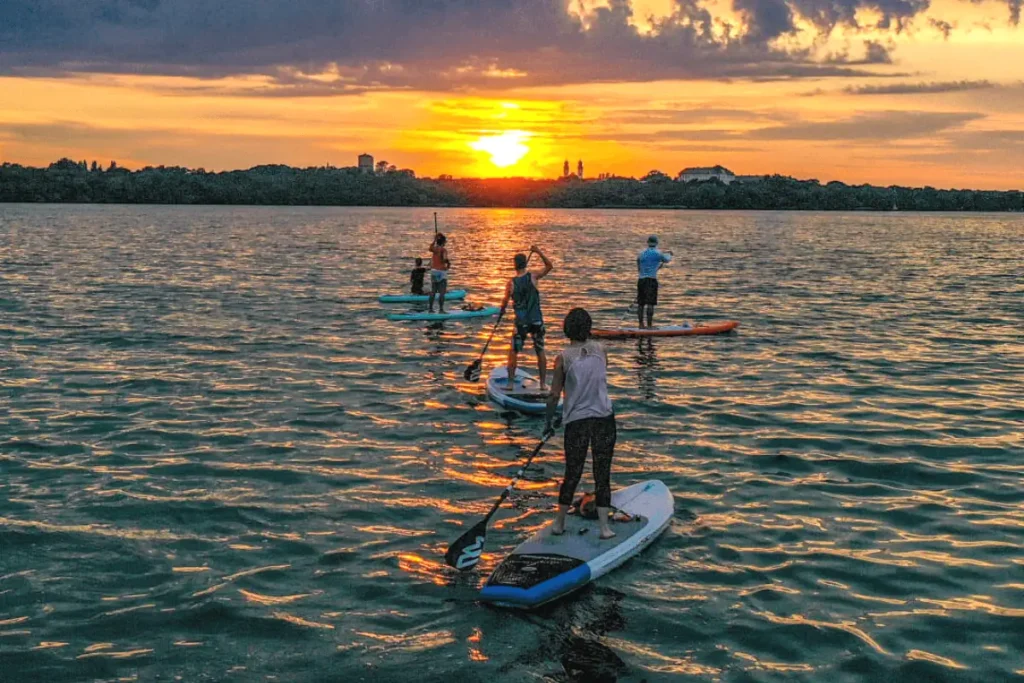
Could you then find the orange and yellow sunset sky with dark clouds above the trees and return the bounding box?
[0,0,1024,189]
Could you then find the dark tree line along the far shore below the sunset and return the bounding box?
[0,159,1024,211]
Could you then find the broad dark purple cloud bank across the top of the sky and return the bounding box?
[0,0,1019,89]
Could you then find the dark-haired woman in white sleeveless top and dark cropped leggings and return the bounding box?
[545,308,616,539]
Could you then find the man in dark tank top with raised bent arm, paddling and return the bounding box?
[502,246,554,391]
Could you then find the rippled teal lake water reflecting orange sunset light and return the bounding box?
[0,205,1024,683]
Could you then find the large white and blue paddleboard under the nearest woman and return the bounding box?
[480,479,675,609]
